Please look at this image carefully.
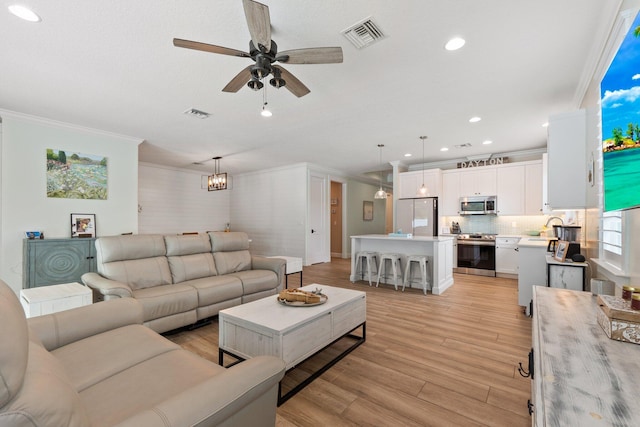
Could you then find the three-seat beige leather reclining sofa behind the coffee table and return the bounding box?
[82,232,286,332]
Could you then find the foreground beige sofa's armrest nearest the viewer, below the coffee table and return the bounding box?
[113,356,285,427]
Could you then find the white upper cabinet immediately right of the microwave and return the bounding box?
[496,164,525,215]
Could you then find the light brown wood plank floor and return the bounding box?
[168,258,531,427]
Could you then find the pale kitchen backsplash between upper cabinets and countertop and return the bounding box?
[440,211,584,235]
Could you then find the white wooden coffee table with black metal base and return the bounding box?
[218,284,367,405]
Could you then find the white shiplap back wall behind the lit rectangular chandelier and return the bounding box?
[138,163,232,234]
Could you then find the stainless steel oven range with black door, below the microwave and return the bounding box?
[453,233,496,277]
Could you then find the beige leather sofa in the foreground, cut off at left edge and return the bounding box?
[0,280,285,427]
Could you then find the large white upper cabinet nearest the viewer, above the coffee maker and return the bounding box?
[547,110,587,209]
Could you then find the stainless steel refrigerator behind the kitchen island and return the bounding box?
[396,197,438,236]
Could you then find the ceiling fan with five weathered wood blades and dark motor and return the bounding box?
[173,0,342,97]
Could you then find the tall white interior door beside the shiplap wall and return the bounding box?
[307,175,331,264]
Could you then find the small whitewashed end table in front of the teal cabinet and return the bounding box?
[20,282,93,317]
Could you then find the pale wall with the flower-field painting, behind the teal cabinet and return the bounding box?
[0,110,142,292]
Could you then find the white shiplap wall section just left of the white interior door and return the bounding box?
[230,165,307,258]
